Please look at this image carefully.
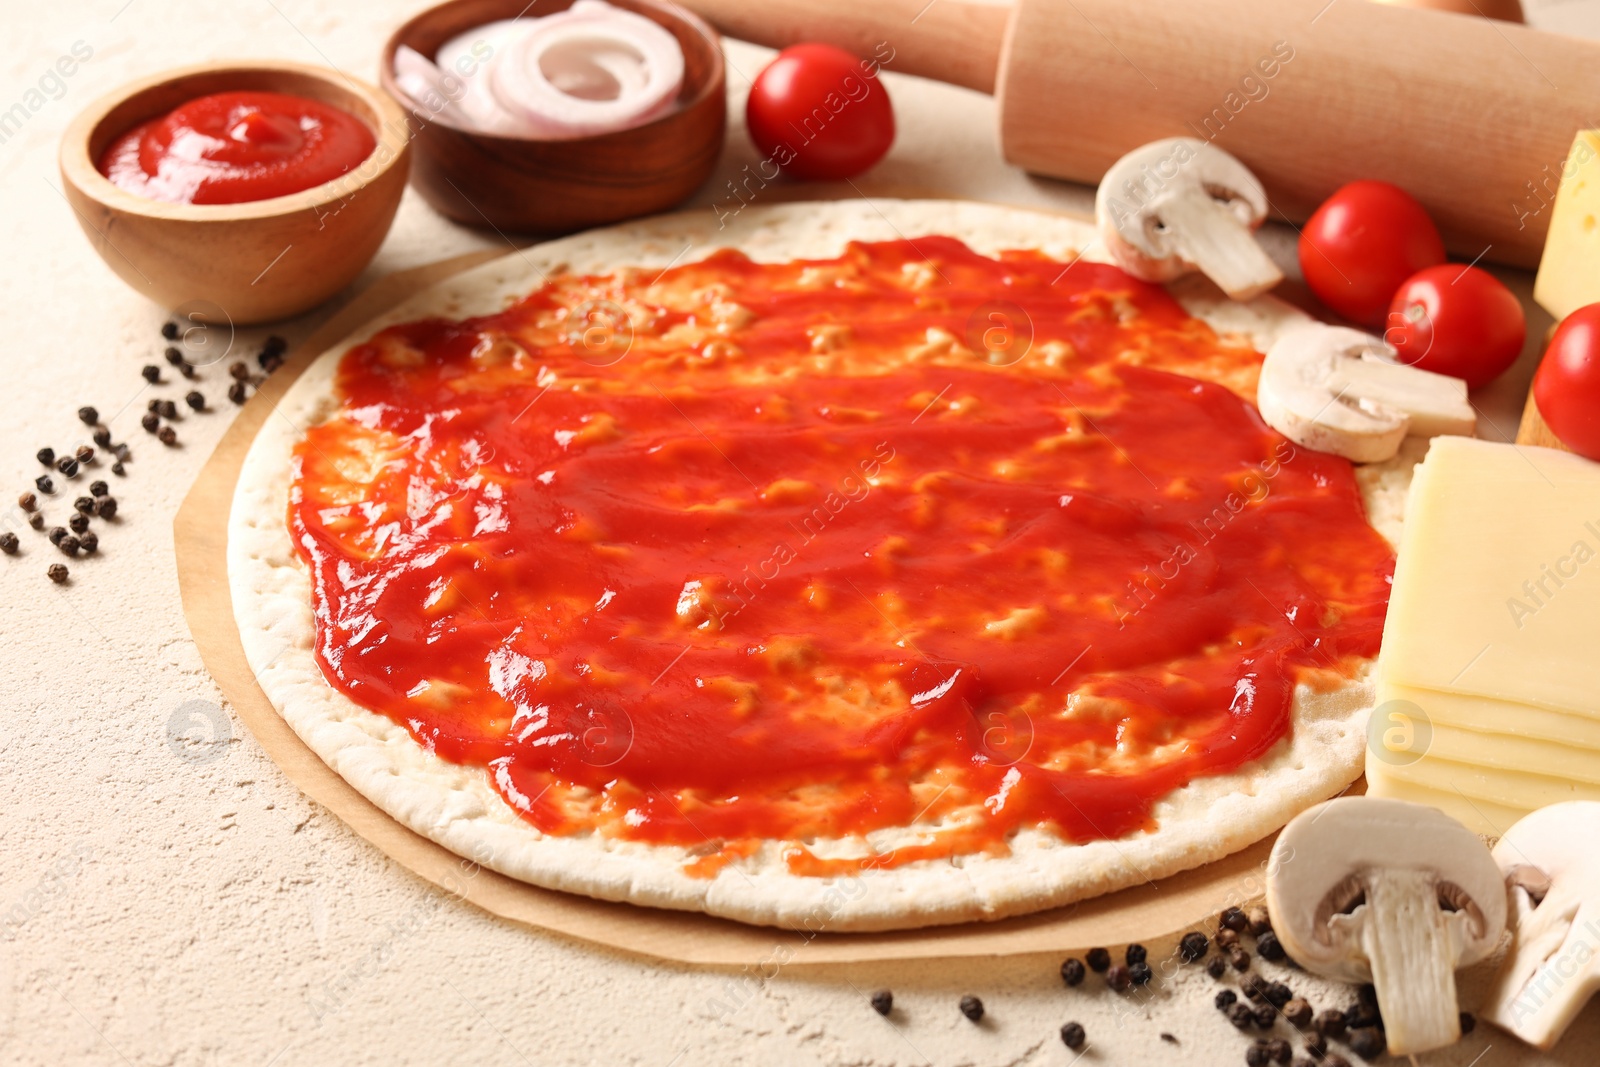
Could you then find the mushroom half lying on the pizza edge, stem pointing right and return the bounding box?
[1256,323,1477,462]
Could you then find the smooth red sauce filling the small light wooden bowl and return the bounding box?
[99,93,378,203]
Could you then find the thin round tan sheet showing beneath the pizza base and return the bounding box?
[173,244,1337,966]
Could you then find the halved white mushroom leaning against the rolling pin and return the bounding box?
[1094,138,1283,301]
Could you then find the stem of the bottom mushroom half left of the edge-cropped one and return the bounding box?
[1360,870,1461,1056]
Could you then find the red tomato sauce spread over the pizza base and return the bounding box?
[290,238,1394,875]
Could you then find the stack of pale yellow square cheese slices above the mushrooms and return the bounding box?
[1366,437,1600,837]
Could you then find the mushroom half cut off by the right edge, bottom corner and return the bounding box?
[1483,800,1600,1049]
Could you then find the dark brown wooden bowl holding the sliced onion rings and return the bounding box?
[379,0,728,234]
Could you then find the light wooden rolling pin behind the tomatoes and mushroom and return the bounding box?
[680,0,1600,267]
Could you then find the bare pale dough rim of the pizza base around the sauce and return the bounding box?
[227,200,1426,931]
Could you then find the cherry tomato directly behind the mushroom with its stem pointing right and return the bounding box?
[1384,262,1528,389]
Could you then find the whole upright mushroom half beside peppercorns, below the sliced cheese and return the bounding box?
[1267,797,1506,1056]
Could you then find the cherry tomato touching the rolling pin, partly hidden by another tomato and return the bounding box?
[1299,181,1445,326]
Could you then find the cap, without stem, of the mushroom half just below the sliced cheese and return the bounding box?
[1267,797,1506,981]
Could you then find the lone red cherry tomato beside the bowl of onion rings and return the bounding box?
[744,45,894,181]
